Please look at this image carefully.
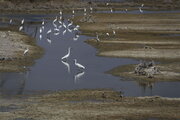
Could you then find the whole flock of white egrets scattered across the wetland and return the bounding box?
[9,3,144,80]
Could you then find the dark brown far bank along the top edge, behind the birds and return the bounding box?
[0,0,180,13]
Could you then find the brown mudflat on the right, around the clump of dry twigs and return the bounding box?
[74,13,180,81]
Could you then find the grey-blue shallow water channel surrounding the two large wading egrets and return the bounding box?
[0,14,180,97]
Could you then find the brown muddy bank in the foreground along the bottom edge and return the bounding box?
[0,90,180,120]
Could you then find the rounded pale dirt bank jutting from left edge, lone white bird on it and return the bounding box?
[0,29,43,72]
